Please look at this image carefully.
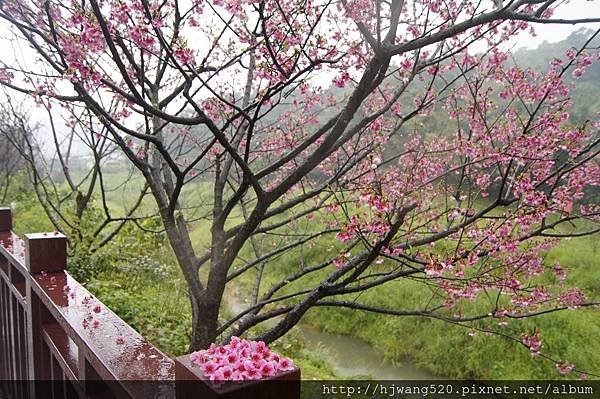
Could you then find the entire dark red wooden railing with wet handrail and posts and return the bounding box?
[0,208,300,399]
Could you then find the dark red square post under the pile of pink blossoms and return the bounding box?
[175,355,300,399]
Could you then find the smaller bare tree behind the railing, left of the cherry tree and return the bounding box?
[0,100,152,280]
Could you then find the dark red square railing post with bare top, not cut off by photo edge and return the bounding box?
[25,233,67,388]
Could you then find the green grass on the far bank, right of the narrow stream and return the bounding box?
[226,212,600,379]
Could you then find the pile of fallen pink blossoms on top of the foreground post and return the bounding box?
[190,337,294,382]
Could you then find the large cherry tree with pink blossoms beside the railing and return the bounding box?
[0,0,600,376]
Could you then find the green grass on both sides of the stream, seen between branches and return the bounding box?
[5,175,600,379]
